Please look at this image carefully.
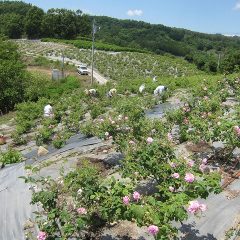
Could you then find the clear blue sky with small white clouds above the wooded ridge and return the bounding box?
[20,0,240,35]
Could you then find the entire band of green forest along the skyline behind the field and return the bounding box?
[0,1,240,73]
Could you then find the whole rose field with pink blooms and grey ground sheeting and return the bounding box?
[0,40,240,240]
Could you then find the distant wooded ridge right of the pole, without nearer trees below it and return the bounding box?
[94,16,240,56]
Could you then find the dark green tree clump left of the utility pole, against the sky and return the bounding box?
[0,1,91,39]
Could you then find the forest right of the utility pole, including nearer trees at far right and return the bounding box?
[95,16,240,72]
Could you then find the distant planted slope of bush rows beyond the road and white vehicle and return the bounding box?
[17,40,201,81]
